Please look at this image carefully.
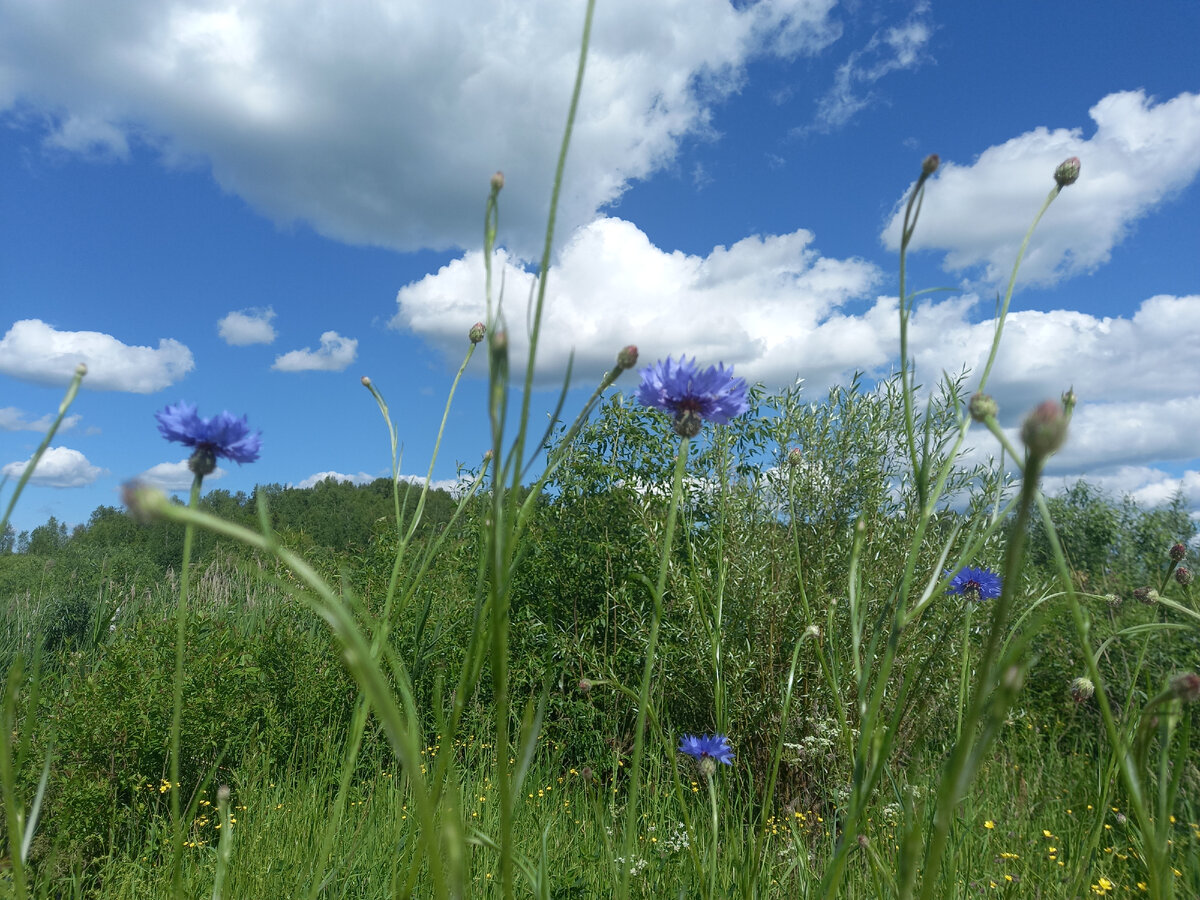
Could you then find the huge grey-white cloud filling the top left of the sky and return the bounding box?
[0,0,840,250]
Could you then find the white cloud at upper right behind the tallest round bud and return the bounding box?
[883,91,1200,284]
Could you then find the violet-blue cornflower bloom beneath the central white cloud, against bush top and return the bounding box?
[637,356,748,438]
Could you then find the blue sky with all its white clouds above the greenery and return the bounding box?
[0,0,1200,529]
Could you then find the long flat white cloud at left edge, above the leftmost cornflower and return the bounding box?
[0,319,196,394]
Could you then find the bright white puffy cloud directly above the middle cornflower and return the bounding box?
[391,218,894,384]
